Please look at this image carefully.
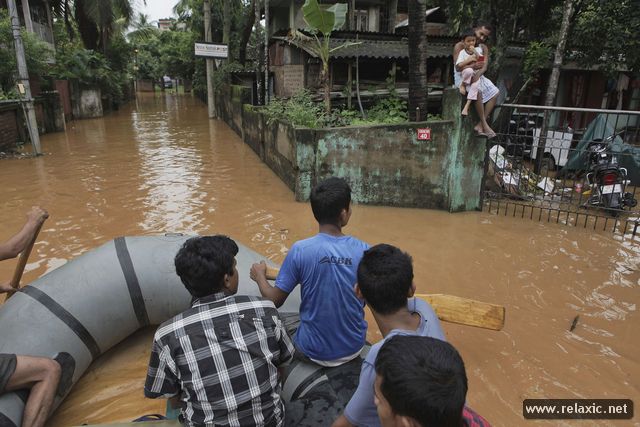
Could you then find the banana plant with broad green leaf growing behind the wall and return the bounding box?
[287,0,360,114]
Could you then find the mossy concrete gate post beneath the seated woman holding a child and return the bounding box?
[442,88,487,212]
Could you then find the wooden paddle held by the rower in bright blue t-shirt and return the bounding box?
[267,267,505,331]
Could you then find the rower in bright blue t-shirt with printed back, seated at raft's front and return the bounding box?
[251,178,369,367]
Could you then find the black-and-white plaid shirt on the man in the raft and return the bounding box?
[144,293,294,427]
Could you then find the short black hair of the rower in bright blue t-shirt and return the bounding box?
[310,177,351,225]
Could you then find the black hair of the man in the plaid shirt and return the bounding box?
[174,235,238,298]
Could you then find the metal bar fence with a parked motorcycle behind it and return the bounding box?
[483,104,640,236]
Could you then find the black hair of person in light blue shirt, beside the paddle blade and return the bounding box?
[358,243,413,314]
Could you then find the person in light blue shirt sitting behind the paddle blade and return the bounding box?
[333,244,445,427]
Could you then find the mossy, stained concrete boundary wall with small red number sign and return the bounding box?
[216,86,485,212]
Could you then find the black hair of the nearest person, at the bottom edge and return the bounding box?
[375,335,467,427]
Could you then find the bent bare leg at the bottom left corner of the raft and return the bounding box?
[7,356,61,427]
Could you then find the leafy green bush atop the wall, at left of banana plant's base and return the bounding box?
[263,90,324,129]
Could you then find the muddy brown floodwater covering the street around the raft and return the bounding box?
[0,94,640,426]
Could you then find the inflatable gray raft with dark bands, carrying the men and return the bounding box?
[0,235,357,427]
